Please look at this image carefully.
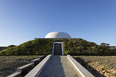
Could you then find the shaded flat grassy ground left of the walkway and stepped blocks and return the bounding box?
[0,55,39,77]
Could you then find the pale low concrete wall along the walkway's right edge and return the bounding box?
[67,55,95,77]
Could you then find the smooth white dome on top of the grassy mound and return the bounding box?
[45,32,71,38]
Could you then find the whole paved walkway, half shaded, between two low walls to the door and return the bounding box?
[39,56,81,77]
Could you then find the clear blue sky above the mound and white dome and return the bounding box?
[0,0,116,46]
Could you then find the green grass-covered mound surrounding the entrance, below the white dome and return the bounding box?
[0,38,116,55]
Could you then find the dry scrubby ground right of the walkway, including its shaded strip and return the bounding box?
[73,56,116,77]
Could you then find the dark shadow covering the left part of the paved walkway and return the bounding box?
[39,56,65,77]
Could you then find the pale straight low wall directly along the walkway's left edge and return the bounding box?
[25,55,51,77]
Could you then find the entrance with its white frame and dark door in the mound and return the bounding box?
[52,42,64,55]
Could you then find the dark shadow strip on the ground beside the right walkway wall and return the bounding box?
[74,57,105,77]
